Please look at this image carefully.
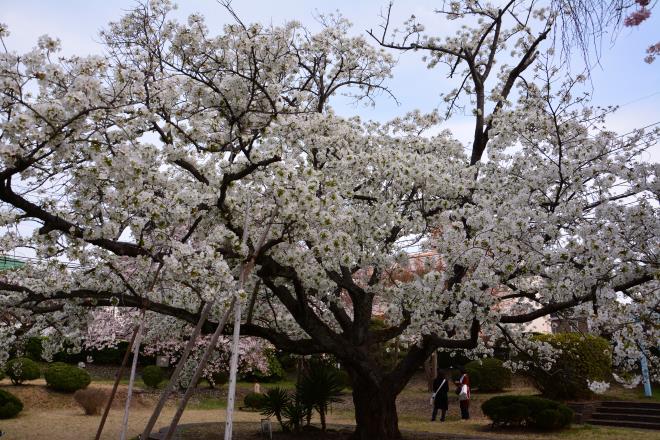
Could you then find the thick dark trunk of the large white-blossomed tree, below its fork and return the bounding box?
[353,378,401,440]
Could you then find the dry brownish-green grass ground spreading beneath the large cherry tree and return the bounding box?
[0,376,660,440]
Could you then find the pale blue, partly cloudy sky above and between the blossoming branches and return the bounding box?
[0,0,660,157]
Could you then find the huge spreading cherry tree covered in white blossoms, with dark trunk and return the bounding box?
[0,1,660,440]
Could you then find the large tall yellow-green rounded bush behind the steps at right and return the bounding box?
[529,333,612,400]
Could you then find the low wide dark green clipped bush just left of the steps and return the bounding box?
[481,396,573,431]
